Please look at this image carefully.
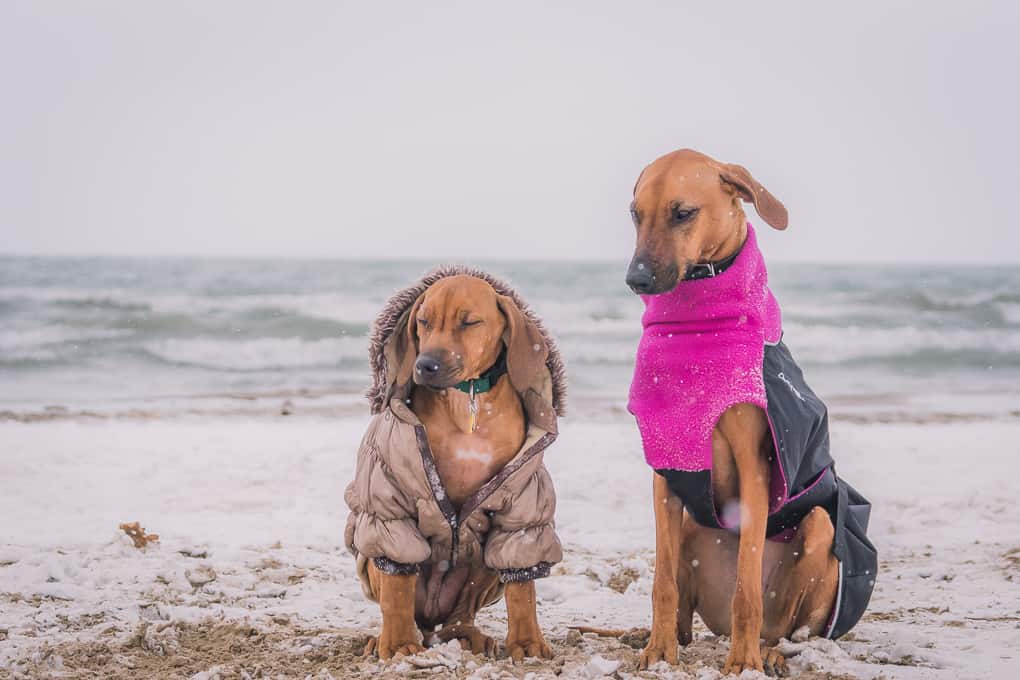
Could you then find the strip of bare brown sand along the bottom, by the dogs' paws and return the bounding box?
[14,619,851,680]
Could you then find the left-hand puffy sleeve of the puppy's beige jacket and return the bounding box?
[344,428,431,574]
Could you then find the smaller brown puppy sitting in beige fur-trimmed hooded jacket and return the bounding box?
[345,267,566,660]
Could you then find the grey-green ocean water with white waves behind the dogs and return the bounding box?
[0,257,1020,419]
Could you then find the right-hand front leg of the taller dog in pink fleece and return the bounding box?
[722,407,769,675]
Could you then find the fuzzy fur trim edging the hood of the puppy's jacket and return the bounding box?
[365,265,567,426]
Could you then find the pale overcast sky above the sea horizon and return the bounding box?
[0,0,1020,262]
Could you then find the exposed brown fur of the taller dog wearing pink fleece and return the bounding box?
[628,150,838,674]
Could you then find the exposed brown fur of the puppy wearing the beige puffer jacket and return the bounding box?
[366,275,552,661]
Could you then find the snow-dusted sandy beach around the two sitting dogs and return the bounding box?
[0,417,1020,680]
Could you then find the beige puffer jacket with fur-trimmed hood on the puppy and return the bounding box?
[345,267,566,583]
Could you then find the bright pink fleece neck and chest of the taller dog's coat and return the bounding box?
[628,224,782,471]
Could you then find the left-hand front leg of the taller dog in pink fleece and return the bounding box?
[638,473,683,670]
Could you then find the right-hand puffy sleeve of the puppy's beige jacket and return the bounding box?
[485,465,563,583]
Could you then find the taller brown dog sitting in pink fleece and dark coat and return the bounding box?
[627,150,877,674]
